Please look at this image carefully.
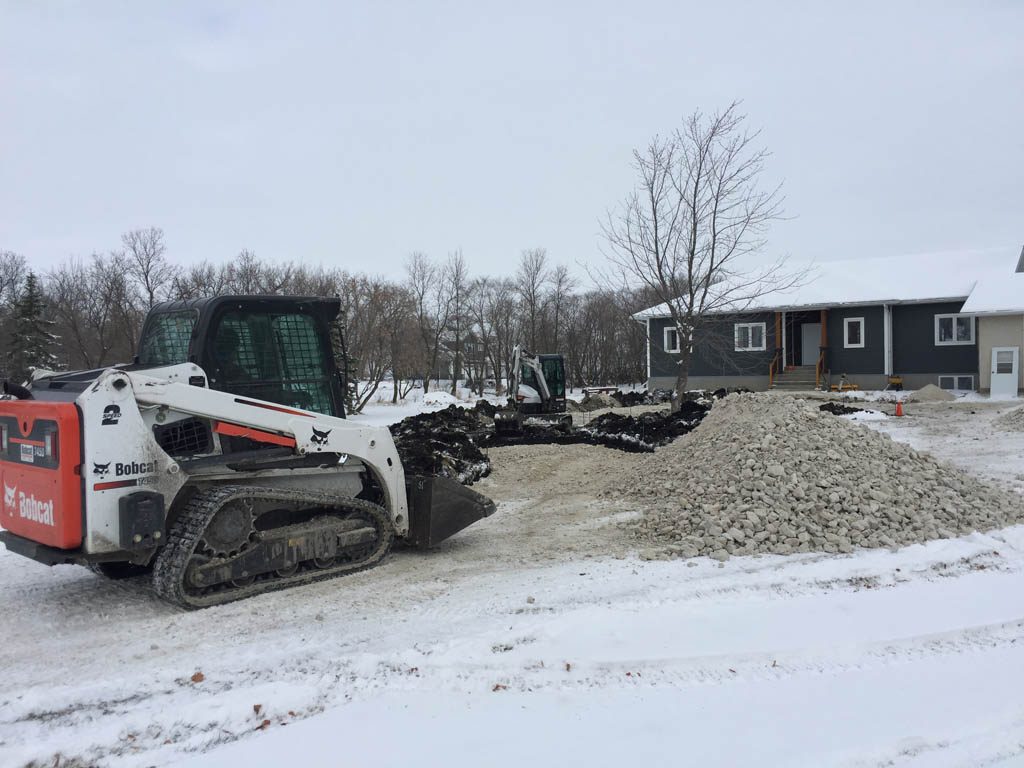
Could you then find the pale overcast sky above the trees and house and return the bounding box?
[0,0,1024,276]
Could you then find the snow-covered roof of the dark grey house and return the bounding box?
[633,249,1024,321]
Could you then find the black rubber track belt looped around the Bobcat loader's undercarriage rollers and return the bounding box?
[153,485,394,608]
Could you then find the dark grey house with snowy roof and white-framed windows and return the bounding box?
[634,251,1024,394]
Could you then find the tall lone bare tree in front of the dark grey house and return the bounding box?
[602,102,804,401]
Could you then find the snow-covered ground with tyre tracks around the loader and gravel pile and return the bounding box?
[0,393,1024,768]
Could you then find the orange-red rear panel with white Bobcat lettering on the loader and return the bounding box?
[0,400,82,549]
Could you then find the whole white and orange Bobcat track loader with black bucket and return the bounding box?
[0,296,495,608]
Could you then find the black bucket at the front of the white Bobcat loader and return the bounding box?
[406,475,496,549]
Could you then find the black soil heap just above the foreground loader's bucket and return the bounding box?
[390,406,490,485]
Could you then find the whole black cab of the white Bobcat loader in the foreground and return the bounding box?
[136,296,345,417]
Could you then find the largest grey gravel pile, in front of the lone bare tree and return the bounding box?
[602,393,1024,560]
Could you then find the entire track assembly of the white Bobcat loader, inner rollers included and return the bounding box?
[153,485,394,608]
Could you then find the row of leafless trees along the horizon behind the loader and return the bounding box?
[0,227,651,410]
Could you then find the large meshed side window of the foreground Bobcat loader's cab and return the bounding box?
[213,312,334,414]
